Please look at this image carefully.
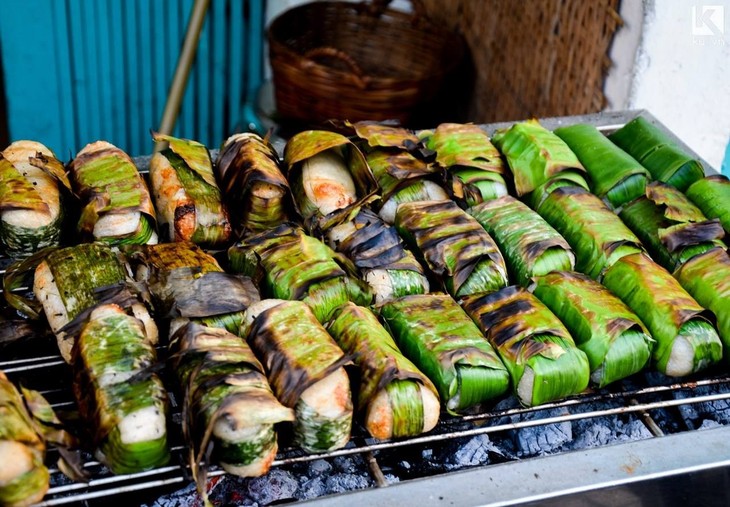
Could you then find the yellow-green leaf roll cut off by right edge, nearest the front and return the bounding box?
[674,248,730,358]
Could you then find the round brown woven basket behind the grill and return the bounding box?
[268,1,464,124]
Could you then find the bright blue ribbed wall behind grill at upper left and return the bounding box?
[0,0,264,159]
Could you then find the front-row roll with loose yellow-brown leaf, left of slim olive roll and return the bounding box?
[246,299,352,452]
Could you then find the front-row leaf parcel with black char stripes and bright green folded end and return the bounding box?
[463,286,590,406]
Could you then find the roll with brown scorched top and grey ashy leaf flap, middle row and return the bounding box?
[128,242,260,334]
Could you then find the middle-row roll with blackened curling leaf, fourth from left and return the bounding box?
[327,209,429,303]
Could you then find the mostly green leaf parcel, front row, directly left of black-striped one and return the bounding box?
[379,294,509,414]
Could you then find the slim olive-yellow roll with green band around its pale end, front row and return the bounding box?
[327,303,439,438]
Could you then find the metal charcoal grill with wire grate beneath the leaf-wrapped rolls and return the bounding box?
[0,111,730,507]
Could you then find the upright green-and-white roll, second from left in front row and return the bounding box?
[73,305,170,474]
